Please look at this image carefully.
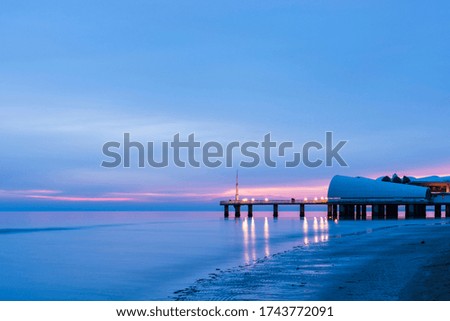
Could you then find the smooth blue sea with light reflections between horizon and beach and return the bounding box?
[0,211,442,300]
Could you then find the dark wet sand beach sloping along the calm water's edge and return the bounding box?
[173,220,450,301]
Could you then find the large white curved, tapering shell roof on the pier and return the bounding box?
[328,175,431,199]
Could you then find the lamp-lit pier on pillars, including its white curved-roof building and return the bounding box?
[220,176,450,220]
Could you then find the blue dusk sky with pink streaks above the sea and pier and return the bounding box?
[0,0,450,211]
